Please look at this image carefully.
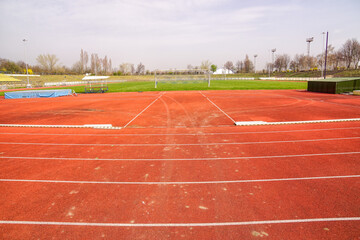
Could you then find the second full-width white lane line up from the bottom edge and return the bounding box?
[0,175,360,185]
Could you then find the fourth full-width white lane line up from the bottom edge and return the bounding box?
[0,137,360,147]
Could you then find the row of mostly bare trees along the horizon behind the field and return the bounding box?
[0,38,360,75]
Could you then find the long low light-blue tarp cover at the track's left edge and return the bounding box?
[5,89,72,99]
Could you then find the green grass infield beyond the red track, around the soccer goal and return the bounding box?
[0,80,307,96]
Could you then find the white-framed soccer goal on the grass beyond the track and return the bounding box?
[154,69,211,88]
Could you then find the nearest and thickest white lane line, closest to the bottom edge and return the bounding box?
[0,217,360,227]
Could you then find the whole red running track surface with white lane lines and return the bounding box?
[0,90,360,240]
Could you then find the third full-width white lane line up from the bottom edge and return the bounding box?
[0,152,360,161]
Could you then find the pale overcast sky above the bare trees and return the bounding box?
[0,0,360,70]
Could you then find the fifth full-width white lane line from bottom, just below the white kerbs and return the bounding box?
[0,127,360,137]
